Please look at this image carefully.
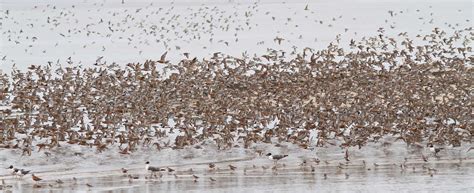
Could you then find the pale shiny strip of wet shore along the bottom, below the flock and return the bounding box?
[4,159,474,192]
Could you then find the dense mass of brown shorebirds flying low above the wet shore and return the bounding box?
[0,28,474,154]
